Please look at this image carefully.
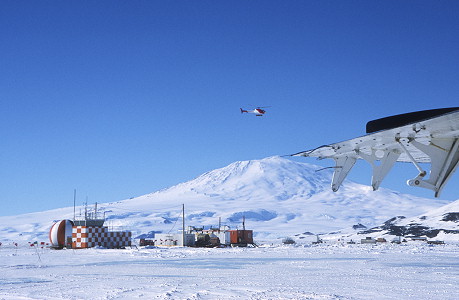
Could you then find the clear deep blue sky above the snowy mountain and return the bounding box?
[0,0,459,215]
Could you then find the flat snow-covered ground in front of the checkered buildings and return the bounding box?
[0,242,459,300]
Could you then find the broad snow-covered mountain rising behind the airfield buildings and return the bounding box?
[0,157,450,240]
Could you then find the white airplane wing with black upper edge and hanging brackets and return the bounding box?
[292,107,459,197]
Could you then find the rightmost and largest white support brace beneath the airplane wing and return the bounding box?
[404,138,459,197]
